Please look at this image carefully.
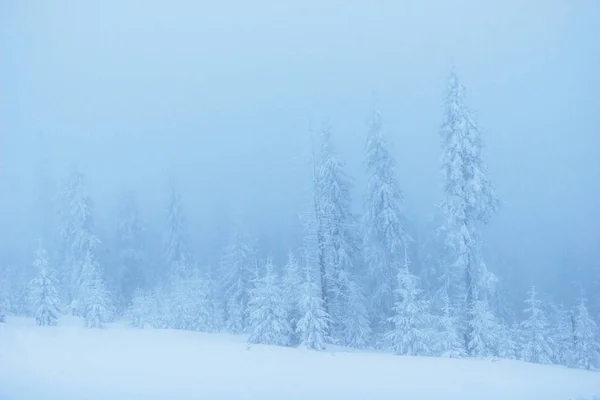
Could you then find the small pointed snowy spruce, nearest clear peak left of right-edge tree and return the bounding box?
[521,286,553,364]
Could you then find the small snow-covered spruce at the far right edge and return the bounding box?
[573,298,600,370]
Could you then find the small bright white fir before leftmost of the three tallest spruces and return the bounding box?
[296,262,330,351]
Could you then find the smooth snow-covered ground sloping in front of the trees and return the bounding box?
[0,318,600,400]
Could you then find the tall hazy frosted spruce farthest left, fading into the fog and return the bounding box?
[59,170,100,315]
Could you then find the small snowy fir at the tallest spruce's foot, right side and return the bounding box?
[466,299,500,357]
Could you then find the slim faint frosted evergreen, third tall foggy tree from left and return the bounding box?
[165,180,191,279]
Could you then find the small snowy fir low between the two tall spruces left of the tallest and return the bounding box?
[340,272,372,349]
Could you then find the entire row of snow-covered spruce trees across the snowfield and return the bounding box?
[0,71,600,369]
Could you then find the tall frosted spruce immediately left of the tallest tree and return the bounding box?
[362,111,408,328]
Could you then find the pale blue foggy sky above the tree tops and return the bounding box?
[0,0,600,300]
